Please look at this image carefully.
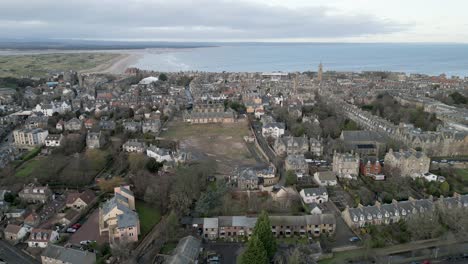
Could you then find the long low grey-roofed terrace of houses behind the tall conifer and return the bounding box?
[184,214,336,240]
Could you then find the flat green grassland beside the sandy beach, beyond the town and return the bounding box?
[0,53,119,77]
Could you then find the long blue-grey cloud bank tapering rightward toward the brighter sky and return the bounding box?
[0,0,408,41]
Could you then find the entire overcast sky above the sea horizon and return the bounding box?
[0,0,468,43]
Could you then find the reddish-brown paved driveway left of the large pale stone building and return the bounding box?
[68,208,108,245]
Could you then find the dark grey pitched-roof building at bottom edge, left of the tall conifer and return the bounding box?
[164,236,201,264]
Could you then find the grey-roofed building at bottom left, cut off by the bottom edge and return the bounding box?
[41,244,96,264]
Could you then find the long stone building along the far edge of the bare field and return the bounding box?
[183,104,236,124]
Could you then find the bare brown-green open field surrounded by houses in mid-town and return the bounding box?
[161,121,264,174]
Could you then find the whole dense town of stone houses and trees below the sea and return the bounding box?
[0,64,468,264]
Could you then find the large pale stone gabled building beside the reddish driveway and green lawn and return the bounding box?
[99,186,140,244]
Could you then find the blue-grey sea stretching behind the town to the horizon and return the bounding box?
[131,43,468,77]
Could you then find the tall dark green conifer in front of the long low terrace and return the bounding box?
[252,211,276,258]
